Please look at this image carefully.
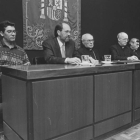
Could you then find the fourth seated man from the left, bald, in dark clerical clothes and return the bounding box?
[110,32,138,60]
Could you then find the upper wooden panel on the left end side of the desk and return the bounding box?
[2,75,27,140]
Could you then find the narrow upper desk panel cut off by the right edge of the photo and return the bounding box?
[133,70,140,109]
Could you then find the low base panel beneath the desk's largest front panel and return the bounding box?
[52,126,93,140]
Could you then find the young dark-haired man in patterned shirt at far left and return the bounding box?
[0,21,30,65]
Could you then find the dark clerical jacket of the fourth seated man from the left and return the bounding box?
[110,44,133,60]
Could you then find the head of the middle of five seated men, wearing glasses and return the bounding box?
[82,33,94,49]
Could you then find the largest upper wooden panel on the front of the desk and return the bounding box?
[33,76,93,140]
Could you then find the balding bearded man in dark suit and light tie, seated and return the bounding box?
[42,23,81,64]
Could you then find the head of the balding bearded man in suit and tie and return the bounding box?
[54,23,71,42]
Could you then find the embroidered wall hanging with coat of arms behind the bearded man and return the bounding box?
[23,0,81,50]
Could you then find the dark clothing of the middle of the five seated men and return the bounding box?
[77,45,100,60]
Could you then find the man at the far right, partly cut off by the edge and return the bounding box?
[129,38,140,59]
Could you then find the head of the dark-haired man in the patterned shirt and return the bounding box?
[0,21,16,42]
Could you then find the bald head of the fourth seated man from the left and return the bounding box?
[117,32,128,47]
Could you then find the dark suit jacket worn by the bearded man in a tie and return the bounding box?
[42,38,80,64]
